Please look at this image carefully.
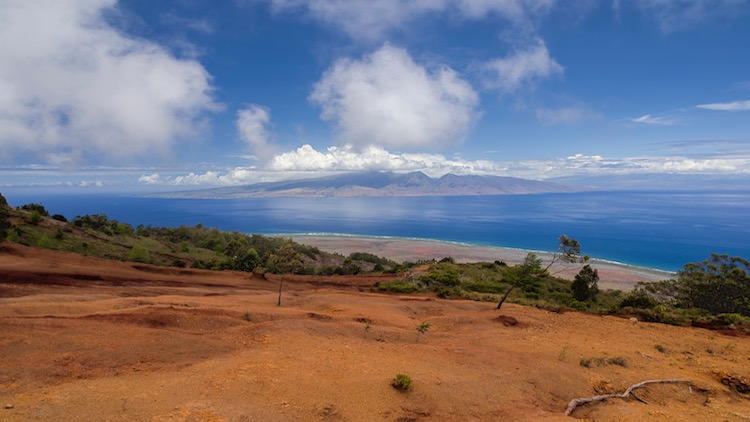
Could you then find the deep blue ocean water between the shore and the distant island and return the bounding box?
[6,191,750,271]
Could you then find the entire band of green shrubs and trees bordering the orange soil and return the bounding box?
[0,195,750,333]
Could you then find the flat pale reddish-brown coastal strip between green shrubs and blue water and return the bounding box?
[290,233,674,291]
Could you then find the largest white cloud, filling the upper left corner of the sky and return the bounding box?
[0,0,218,163]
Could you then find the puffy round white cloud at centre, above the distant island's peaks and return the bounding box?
[310,44,480,149]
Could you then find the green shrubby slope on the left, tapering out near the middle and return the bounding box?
[0,195,405,275]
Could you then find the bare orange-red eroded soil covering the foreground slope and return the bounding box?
[0,244,750,421]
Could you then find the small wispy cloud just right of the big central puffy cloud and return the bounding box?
[484,39,564,93]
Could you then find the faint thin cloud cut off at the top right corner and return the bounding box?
[636,0,746,33]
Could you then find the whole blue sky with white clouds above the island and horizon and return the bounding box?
[0,0,750,191]
